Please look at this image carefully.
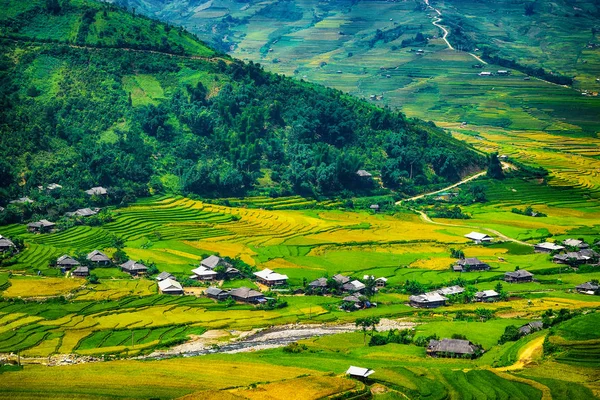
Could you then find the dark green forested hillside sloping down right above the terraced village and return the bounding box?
[0,0,485,222]
